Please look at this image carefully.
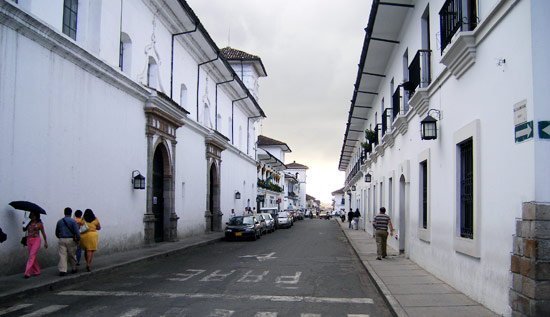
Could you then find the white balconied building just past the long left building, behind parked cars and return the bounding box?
[256,135,291,210]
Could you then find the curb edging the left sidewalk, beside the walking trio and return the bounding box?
[0,236,224,303]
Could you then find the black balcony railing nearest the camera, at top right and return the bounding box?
[439,0,477,53]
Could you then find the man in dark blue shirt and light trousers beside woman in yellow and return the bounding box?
[55,207,80,276]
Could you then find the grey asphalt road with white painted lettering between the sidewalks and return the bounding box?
[0,219,391,317]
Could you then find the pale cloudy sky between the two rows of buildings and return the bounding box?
[187,0,371,203]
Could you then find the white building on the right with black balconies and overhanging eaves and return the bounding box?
[339,0,550,316]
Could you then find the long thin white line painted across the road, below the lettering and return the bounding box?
[57,290,374,304]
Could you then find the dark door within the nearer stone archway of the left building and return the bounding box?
[153,144,168,242]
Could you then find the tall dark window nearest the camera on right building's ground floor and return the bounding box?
[458,138,474,239]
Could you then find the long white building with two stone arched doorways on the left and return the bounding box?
[0,0,266,274]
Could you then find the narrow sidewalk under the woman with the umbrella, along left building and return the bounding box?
[0,232,224,304]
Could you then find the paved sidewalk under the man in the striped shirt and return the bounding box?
[337,220,497,317]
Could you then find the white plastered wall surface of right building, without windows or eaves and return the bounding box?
[352,1,549,315]
